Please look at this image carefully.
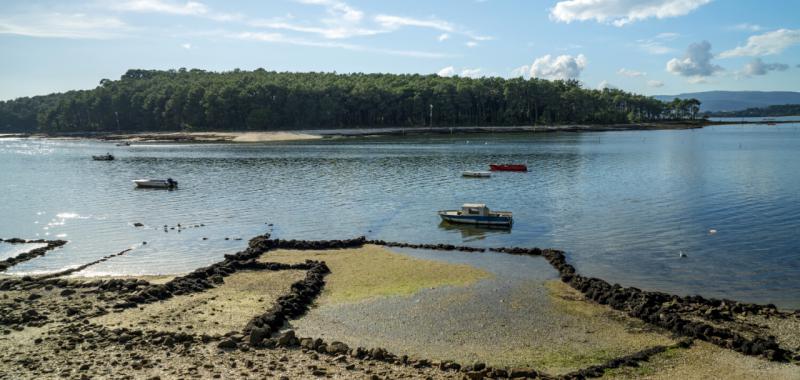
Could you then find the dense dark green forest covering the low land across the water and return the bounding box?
[0,68,700,133]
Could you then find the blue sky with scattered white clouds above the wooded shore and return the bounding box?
[0,0,800,100]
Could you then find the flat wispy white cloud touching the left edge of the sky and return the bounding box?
[0,13,130,39]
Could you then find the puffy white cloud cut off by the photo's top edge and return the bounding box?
[550,0,711,26]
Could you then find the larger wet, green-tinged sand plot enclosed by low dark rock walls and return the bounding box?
[261,246,675,374]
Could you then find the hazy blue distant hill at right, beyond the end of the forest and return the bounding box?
[654,91,800,112]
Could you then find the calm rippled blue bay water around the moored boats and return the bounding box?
[0,124,800,308]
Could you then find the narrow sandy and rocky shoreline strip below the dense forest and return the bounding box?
[0,120,797,143]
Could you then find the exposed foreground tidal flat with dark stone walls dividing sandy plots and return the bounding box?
[0,236,800,379]
